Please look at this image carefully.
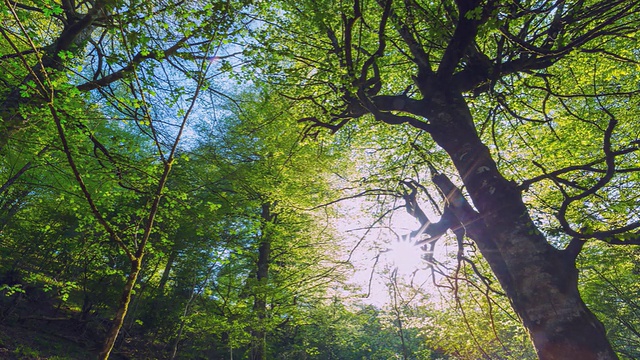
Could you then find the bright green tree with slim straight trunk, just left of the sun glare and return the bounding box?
[194,88,350,360]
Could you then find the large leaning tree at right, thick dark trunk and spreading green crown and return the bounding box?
[247,0,640,359]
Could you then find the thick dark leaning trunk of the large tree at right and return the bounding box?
[424,89,617,360]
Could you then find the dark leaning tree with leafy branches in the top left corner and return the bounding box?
[0,0,243,150]
